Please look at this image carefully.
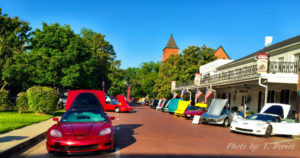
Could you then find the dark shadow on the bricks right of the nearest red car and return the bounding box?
[115,124,142,150]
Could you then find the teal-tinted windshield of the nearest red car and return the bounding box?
[60,110,105,123]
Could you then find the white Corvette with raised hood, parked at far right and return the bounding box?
[230,103,300,137]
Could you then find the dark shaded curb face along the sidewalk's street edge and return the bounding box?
[0,132,46,157]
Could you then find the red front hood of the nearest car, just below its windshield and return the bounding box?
[60,122,105,135]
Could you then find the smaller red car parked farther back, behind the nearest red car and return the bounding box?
[106,95,131,112]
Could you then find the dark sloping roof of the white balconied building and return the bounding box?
[219,35,300,68]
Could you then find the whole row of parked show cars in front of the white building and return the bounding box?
[143,99,300,137]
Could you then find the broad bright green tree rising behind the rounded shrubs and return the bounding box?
[28,23,96,89]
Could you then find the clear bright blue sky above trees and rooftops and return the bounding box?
[0,0,300,68]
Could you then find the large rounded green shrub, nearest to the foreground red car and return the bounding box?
[27,86,58,114]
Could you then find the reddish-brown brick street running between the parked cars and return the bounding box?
[15,105,300,158]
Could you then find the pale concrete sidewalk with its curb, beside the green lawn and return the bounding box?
[0,118,56,157]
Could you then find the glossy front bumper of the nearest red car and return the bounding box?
[46,135,115,153]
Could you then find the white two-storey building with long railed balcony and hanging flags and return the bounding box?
[172,36,300,118]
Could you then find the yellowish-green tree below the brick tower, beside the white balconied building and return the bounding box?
[154,45,216,98]
